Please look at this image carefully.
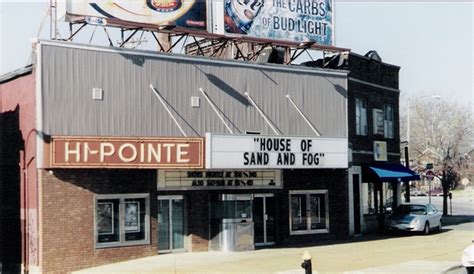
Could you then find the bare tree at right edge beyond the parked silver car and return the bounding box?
[401,98,474,215]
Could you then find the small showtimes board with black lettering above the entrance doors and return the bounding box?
[158,170,283,190]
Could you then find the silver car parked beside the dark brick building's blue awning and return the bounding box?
[386,204,442,235]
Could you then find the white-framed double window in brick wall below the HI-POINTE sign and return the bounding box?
[95,194,150,248]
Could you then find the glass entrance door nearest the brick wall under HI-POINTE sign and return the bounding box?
[158,195,185,253]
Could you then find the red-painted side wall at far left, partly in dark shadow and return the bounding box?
[0,70,38,272]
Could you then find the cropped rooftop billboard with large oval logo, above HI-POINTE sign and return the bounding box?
[66,0,207,30]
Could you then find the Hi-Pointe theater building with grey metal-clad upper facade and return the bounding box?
[0,41,355,272]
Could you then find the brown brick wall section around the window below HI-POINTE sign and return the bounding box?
[39,170,157,272]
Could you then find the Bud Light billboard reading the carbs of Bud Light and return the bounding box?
[218,0,334,45]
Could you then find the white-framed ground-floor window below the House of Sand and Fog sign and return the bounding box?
[290,190,329,235]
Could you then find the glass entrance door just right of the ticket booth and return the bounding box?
[253,193,275,246]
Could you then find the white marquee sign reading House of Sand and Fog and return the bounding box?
[206,133,348,169]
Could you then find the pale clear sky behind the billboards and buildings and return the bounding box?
[0,0,474,111]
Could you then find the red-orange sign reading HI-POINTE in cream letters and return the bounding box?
[49,136,204,168]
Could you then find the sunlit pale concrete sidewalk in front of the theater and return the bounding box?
[75,223,474,274]
